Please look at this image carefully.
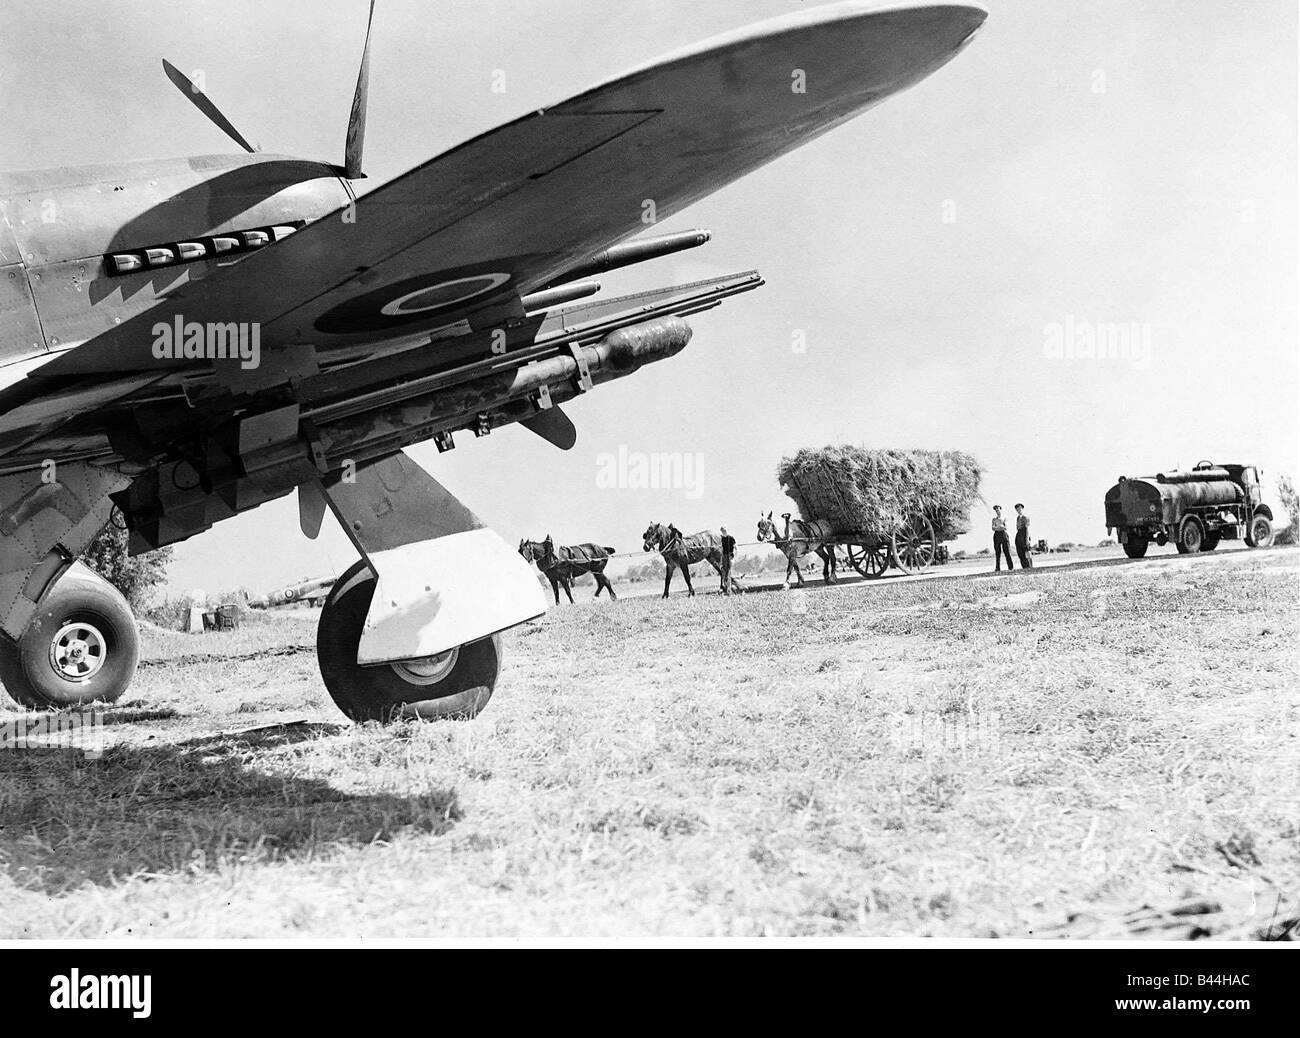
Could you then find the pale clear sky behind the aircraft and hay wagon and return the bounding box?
[0,0,1300,591]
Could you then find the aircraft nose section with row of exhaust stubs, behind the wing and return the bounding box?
[0,155,352,371]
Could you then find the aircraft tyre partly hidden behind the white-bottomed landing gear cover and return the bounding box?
[316,562,501,723]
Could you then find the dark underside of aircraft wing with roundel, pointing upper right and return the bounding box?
[29,0,985,381]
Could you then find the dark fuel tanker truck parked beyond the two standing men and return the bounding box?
[1106,462,1273,558]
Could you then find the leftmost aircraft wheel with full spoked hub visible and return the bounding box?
[0,562,140,710]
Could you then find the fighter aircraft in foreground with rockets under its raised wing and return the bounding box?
[0,0,985,721]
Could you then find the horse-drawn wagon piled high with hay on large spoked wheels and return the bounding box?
[777,447,980,579]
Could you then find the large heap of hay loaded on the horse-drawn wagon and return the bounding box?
[776,445,980,541]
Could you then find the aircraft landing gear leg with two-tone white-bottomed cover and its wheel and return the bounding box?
[306,451,546,722]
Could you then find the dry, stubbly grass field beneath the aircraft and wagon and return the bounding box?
[0,549,1300,938]
